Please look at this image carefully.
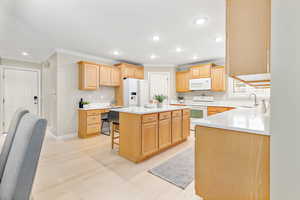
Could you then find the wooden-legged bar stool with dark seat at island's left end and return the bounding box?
[108,111,120,149]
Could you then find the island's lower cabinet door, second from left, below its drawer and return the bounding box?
[158,118,172,149]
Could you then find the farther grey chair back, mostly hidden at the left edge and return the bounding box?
[0,108,29,182]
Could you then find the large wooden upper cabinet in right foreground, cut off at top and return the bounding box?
[226,0,271,76]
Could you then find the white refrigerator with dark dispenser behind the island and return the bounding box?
[123,78,150,106]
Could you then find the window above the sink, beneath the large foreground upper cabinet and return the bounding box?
[228,78,271,98]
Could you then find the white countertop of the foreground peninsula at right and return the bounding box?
[193,108,271,135]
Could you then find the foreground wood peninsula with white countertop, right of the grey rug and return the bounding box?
[195,108,270,200]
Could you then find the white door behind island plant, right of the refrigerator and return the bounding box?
[148,72,170,101]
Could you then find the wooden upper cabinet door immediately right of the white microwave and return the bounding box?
[211,66,226,92]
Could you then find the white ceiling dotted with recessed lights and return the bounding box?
[0,0,225,65]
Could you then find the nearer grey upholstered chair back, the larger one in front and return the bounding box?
[0,113,47,200]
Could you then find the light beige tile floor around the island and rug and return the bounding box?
[32,132,202,200]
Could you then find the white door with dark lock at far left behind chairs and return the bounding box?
[3,68,40,132]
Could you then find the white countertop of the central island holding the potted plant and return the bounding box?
[111,105,189,114]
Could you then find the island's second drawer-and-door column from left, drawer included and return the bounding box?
[158,112,172,149]
